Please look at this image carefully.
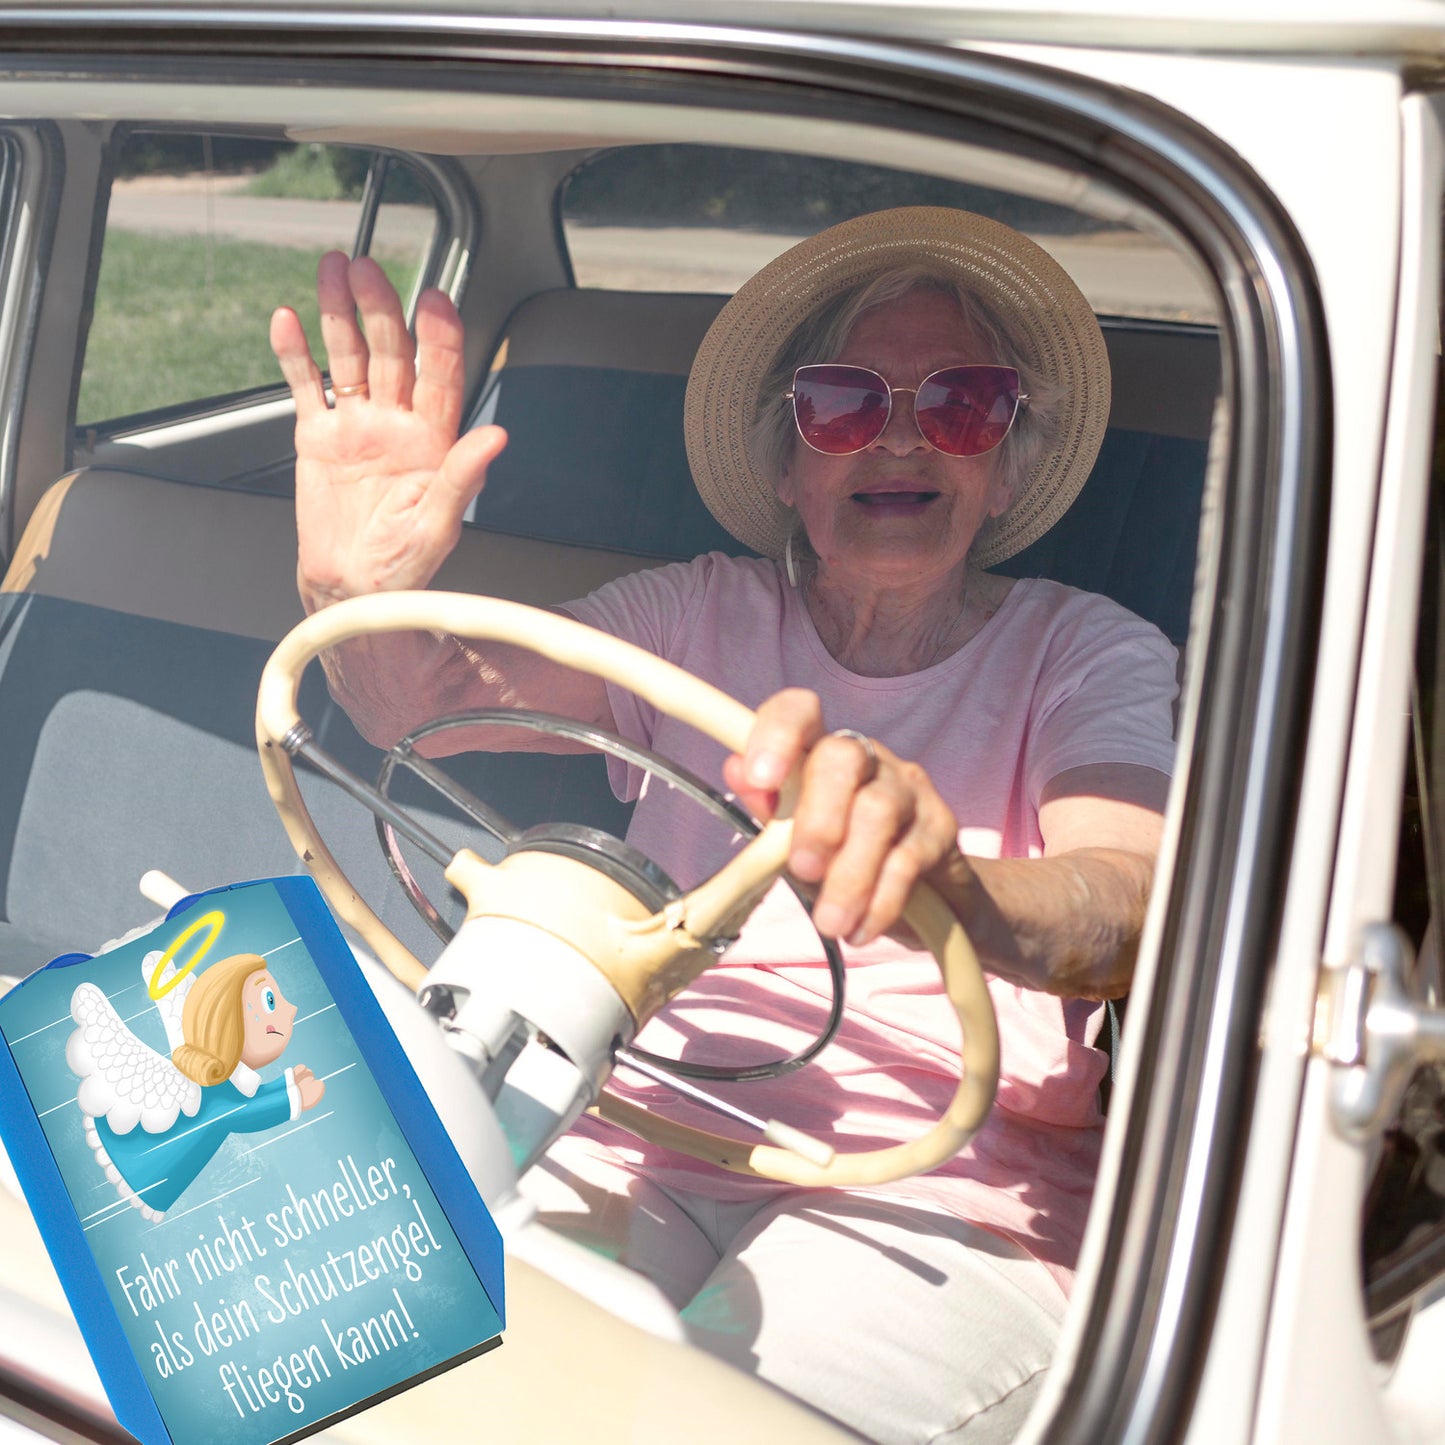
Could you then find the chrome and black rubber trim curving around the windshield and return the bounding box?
[0,9,1329,1445]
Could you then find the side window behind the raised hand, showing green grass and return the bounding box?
[75,131,438,426]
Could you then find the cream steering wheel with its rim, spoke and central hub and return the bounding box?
[256,592,998,1188]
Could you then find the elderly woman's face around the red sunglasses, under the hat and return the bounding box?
[777,290,1012,587]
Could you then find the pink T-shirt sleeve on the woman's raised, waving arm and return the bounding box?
[562,556,711,802]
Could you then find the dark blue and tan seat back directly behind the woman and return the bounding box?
[473,290,1220,643]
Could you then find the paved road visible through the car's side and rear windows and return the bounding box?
[110,182,1214,321]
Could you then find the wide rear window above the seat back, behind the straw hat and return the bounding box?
[562,145,1215,324]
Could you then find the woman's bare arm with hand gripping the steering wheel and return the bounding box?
[724,689,1169,998]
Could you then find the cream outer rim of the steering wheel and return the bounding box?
[256,592,998,1186]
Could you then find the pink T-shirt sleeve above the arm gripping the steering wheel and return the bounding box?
[1026,594,1179,805]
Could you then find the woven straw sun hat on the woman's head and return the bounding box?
[683,205,1110,566]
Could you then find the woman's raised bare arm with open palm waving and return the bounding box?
[270,251,611,749]
